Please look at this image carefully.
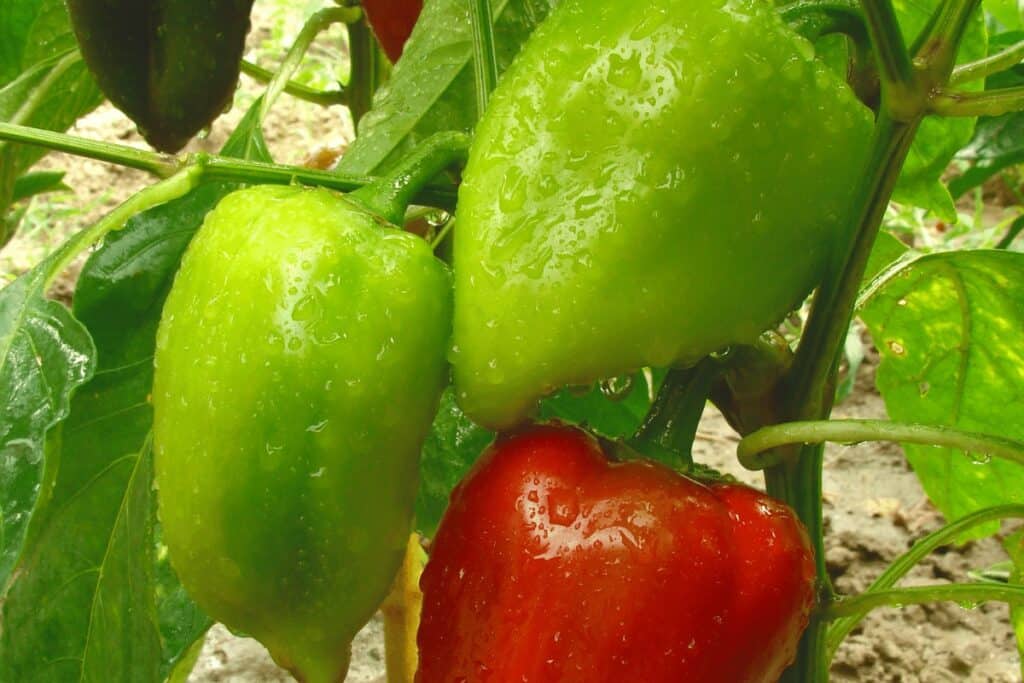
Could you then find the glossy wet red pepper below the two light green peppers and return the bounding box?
[416,426,815,683]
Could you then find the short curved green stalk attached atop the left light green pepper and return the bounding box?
[349,131,469,225]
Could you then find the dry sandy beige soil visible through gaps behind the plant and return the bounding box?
[0,7,1021,683]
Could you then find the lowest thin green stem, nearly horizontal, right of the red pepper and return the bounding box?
[825,584,1024,620]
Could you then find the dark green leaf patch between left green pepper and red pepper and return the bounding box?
[416,387,495,538]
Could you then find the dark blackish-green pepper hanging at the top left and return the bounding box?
[67,0,253,152]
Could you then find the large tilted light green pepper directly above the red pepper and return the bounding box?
[453,0,871,429]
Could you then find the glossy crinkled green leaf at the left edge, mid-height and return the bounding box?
[0,255,95,587]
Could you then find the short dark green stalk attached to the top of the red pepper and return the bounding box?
[629,358,720,468]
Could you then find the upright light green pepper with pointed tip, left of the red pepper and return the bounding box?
[153,186,451,683]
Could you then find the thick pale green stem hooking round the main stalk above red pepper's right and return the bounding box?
[736,420,1024,470]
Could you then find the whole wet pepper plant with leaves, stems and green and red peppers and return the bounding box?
[0,0,1024,683]
